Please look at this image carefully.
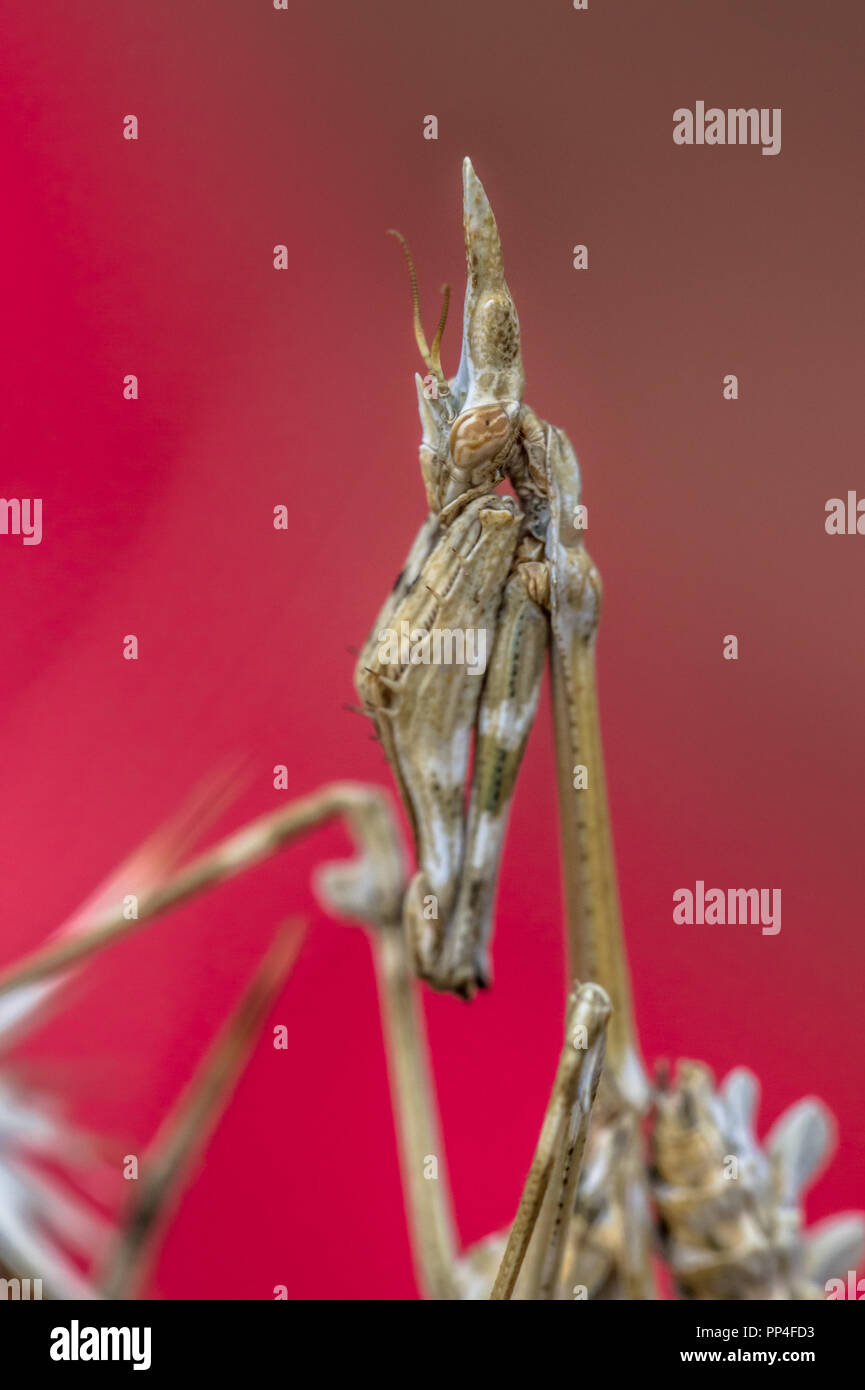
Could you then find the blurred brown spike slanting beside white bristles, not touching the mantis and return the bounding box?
[103,923,305,1298]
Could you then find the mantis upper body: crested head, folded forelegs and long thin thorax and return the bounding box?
[355,158,647,1106]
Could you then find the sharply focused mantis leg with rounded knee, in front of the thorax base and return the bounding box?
[491,984,611,1300]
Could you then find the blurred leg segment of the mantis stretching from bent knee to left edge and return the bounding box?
[0,783,389,995]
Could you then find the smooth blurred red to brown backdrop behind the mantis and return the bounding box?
[0,0,865,1298]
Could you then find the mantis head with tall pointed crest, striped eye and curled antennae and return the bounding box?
[394,158,526,512]
